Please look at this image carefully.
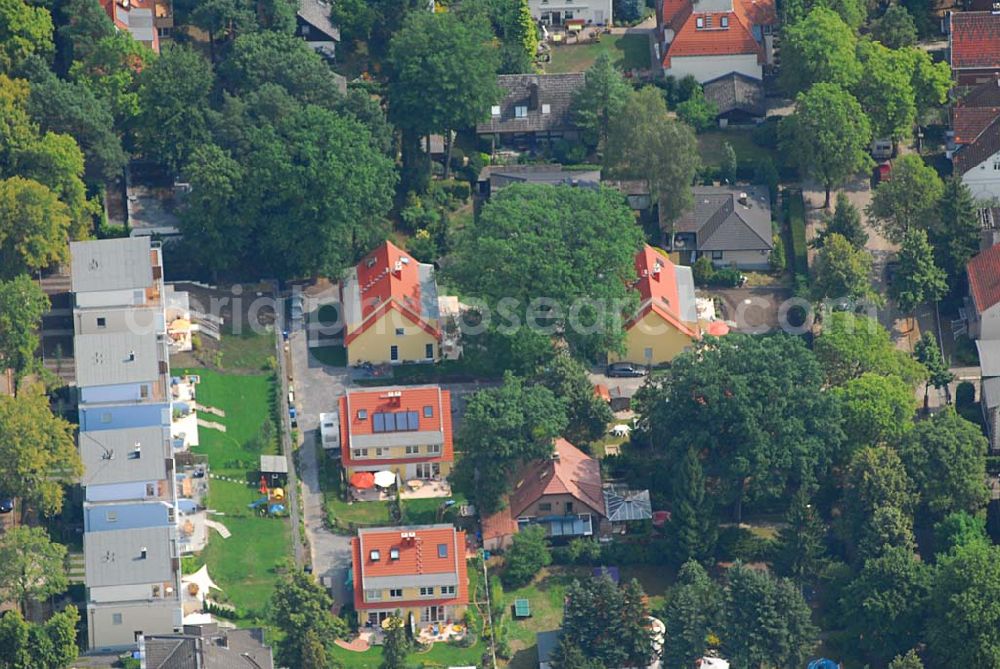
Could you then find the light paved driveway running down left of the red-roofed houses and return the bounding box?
[289,329,352,606]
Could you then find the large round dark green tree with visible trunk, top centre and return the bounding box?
[388,12,501,178]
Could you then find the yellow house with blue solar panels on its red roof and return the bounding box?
[340,386,455,481]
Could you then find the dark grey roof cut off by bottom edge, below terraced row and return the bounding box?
[143,623,274,669]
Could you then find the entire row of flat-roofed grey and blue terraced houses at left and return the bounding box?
[70,237,195,649]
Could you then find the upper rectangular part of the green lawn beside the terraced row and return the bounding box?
[177,369,278,477]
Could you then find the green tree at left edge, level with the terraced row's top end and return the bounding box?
[0,274,50,376]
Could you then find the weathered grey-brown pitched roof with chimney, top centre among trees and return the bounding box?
[476,72,584,134]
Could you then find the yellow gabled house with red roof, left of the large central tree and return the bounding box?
[340,241,441,365]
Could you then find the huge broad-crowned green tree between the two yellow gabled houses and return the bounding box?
[449,184,642,359]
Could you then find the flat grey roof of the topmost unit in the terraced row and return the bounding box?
[69,237,153,293]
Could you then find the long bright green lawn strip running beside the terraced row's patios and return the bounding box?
[178,366,291,624]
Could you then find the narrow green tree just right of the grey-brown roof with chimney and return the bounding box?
[573,52,632,148]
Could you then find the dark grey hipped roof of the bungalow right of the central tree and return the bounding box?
[674,186,773,251]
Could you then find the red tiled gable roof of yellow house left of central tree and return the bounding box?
[344,240,439,345]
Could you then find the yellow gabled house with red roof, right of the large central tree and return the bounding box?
[618,244,729,365]
